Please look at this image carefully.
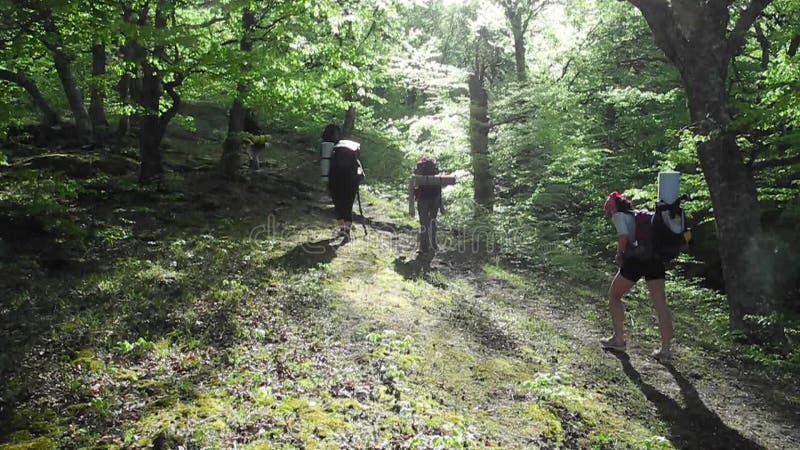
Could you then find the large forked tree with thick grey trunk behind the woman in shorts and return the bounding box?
[628,0,773,332]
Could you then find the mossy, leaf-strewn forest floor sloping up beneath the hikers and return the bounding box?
[0,134,800,450]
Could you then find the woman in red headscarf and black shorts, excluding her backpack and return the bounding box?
[600,192,673,362]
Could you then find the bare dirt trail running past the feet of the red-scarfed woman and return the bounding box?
[340,200,800,449]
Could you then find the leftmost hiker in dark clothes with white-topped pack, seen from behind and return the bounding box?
[328,140,365,244]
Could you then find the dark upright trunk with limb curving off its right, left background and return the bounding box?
[139,63,166,184]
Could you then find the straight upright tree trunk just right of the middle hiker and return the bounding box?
[469,74,494,215]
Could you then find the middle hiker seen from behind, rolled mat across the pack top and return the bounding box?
[414,156,444,254]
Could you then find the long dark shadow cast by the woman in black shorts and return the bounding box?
[611,352,764,450]
